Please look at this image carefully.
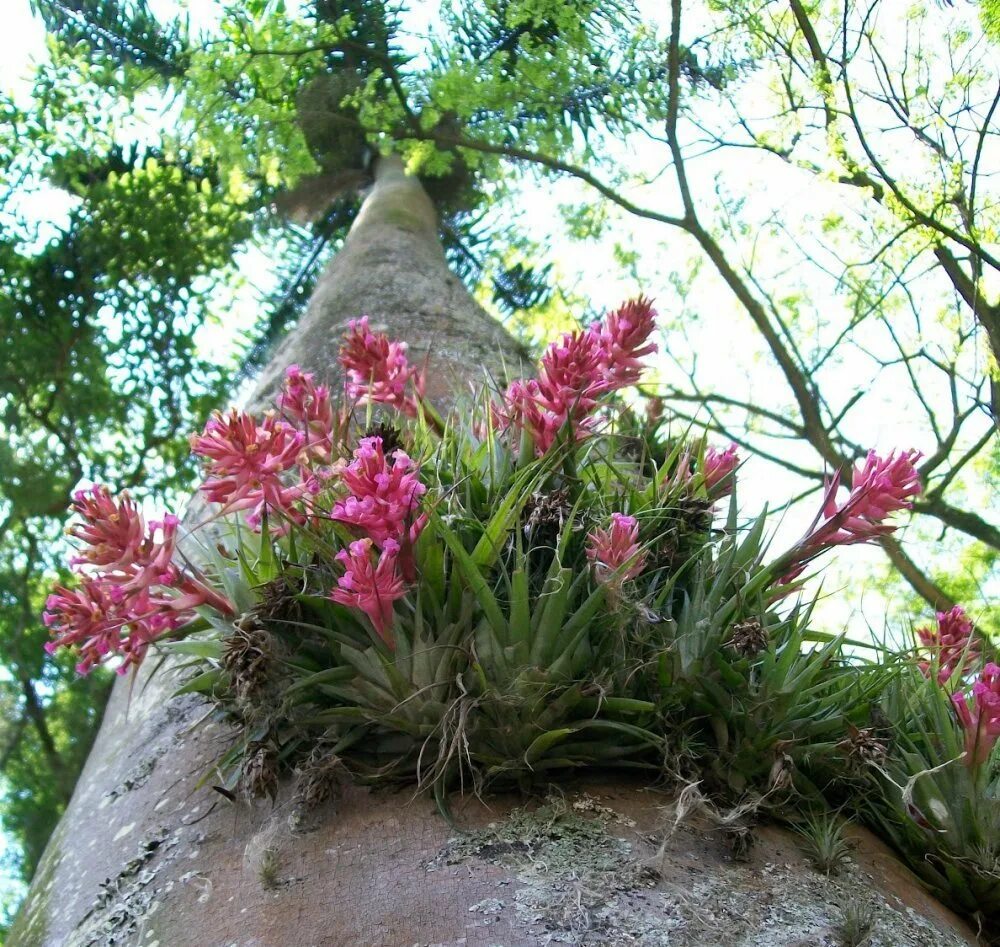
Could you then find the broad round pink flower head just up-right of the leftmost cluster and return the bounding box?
[191,408,306,522]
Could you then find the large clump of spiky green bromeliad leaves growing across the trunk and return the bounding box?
[163,386,877,828]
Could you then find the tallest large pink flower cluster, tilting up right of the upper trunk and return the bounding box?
[493,298,656,454]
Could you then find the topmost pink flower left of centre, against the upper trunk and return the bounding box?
[340,316,424,417]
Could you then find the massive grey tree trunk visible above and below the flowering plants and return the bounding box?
[8,159,972,947]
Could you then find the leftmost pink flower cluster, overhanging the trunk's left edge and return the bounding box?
[42,485,232,674]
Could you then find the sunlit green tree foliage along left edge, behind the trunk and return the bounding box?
[0,20,251,912]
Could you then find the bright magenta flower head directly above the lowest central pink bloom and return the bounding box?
[332,437,427,549]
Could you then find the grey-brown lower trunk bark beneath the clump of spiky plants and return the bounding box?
[7,704,974,947]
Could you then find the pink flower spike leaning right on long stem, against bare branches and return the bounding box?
[779,450,921,583]
